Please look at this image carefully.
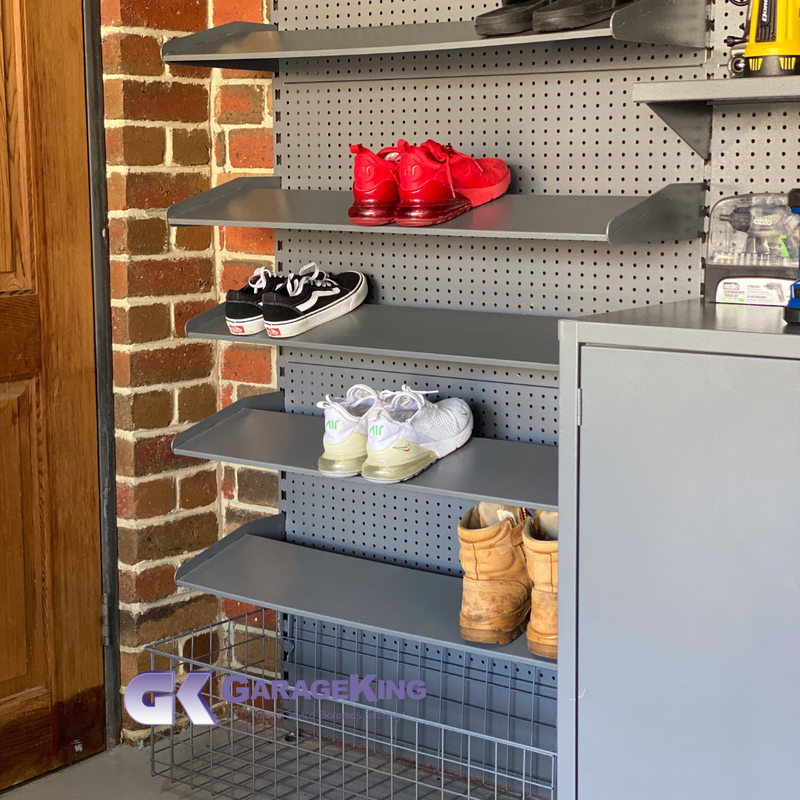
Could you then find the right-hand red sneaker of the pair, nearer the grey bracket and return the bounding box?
[394,139,511,227]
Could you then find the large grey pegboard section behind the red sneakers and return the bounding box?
[275,69,703,195]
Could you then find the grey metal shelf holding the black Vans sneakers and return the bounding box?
[186,304,558,371]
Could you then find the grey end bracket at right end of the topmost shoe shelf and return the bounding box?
[611,0,709,49]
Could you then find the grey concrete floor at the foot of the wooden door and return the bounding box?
[0,746,213,800]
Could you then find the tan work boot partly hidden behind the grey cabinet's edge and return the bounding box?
[522,511,558,658]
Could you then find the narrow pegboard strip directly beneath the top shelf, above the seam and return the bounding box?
[281,39,705,83]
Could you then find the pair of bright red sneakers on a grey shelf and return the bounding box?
[348,139,511,227]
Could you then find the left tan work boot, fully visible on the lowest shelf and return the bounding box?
[458,503,532,644]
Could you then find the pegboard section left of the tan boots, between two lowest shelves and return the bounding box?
[281,472,472,575]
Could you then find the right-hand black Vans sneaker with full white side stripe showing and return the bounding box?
[262,263,368,339]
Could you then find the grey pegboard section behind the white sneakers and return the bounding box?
[280,359,558,445]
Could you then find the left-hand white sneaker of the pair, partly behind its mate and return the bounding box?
[317,384,381,478]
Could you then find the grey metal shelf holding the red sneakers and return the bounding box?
[167,178,705,244]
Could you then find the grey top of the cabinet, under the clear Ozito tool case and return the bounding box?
[561,299,800,358]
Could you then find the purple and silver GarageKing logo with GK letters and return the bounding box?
[125,670,425,725]
